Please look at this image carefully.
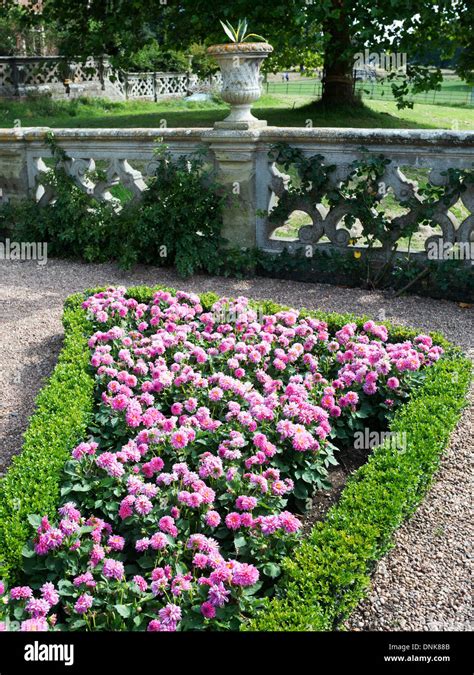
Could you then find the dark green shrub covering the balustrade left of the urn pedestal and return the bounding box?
[0,136,224,277]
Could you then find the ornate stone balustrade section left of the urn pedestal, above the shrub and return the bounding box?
[0,128,206,206]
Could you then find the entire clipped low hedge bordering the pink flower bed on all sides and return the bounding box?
[0,286,471,631]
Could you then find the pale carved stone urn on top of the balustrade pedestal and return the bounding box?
[207,42,273,129]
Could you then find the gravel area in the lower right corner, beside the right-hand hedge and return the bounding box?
[347,380,474,631]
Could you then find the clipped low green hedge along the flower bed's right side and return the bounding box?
[245,353,471,631]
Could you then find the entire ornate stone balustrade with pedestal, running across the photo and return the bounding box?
[0,127,474,256]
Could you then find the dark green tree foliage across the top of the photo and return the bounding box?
[4,0,474,103]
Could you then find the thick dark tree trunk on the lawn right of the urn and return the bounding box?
[321,0,355,106]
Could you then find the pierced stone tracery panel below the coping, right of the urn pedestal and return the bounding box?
[260,146,474,255]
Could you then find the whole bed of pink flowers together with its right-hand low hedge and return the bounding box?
[0,289,468,630]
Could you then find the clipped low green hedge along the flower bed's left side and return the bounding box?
[0,295,94,580]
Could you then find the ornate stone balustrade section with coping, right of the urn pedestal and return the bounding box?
[255,127,474,256]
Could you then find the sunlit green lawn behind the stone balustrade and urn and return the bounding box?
[0,94,474,130]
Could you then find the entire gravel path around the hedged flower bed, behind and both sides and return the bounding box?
[0,260,474,630]
